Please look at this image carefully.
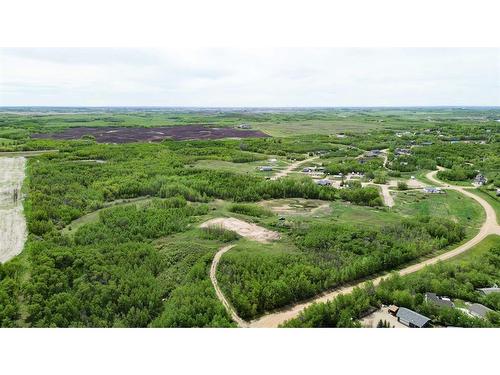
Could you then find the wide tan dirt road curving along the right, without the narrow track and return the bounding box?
[213,171,500,328]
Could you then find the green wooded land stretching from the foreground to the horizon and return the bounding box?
[0,109,500,327]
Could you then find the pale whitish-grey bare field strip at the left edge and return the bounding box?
[0,157,26,263]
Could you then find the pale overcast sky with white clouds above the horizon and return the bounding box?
[0,48,500,107]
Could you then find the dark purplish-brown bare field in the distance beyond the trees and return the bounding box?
[31,125,269,143]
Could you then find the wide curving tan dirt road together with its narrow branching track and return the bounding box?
[210,168,500,328]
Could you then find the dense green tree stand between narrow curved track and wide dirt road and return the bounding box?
[218,218,464,319]
